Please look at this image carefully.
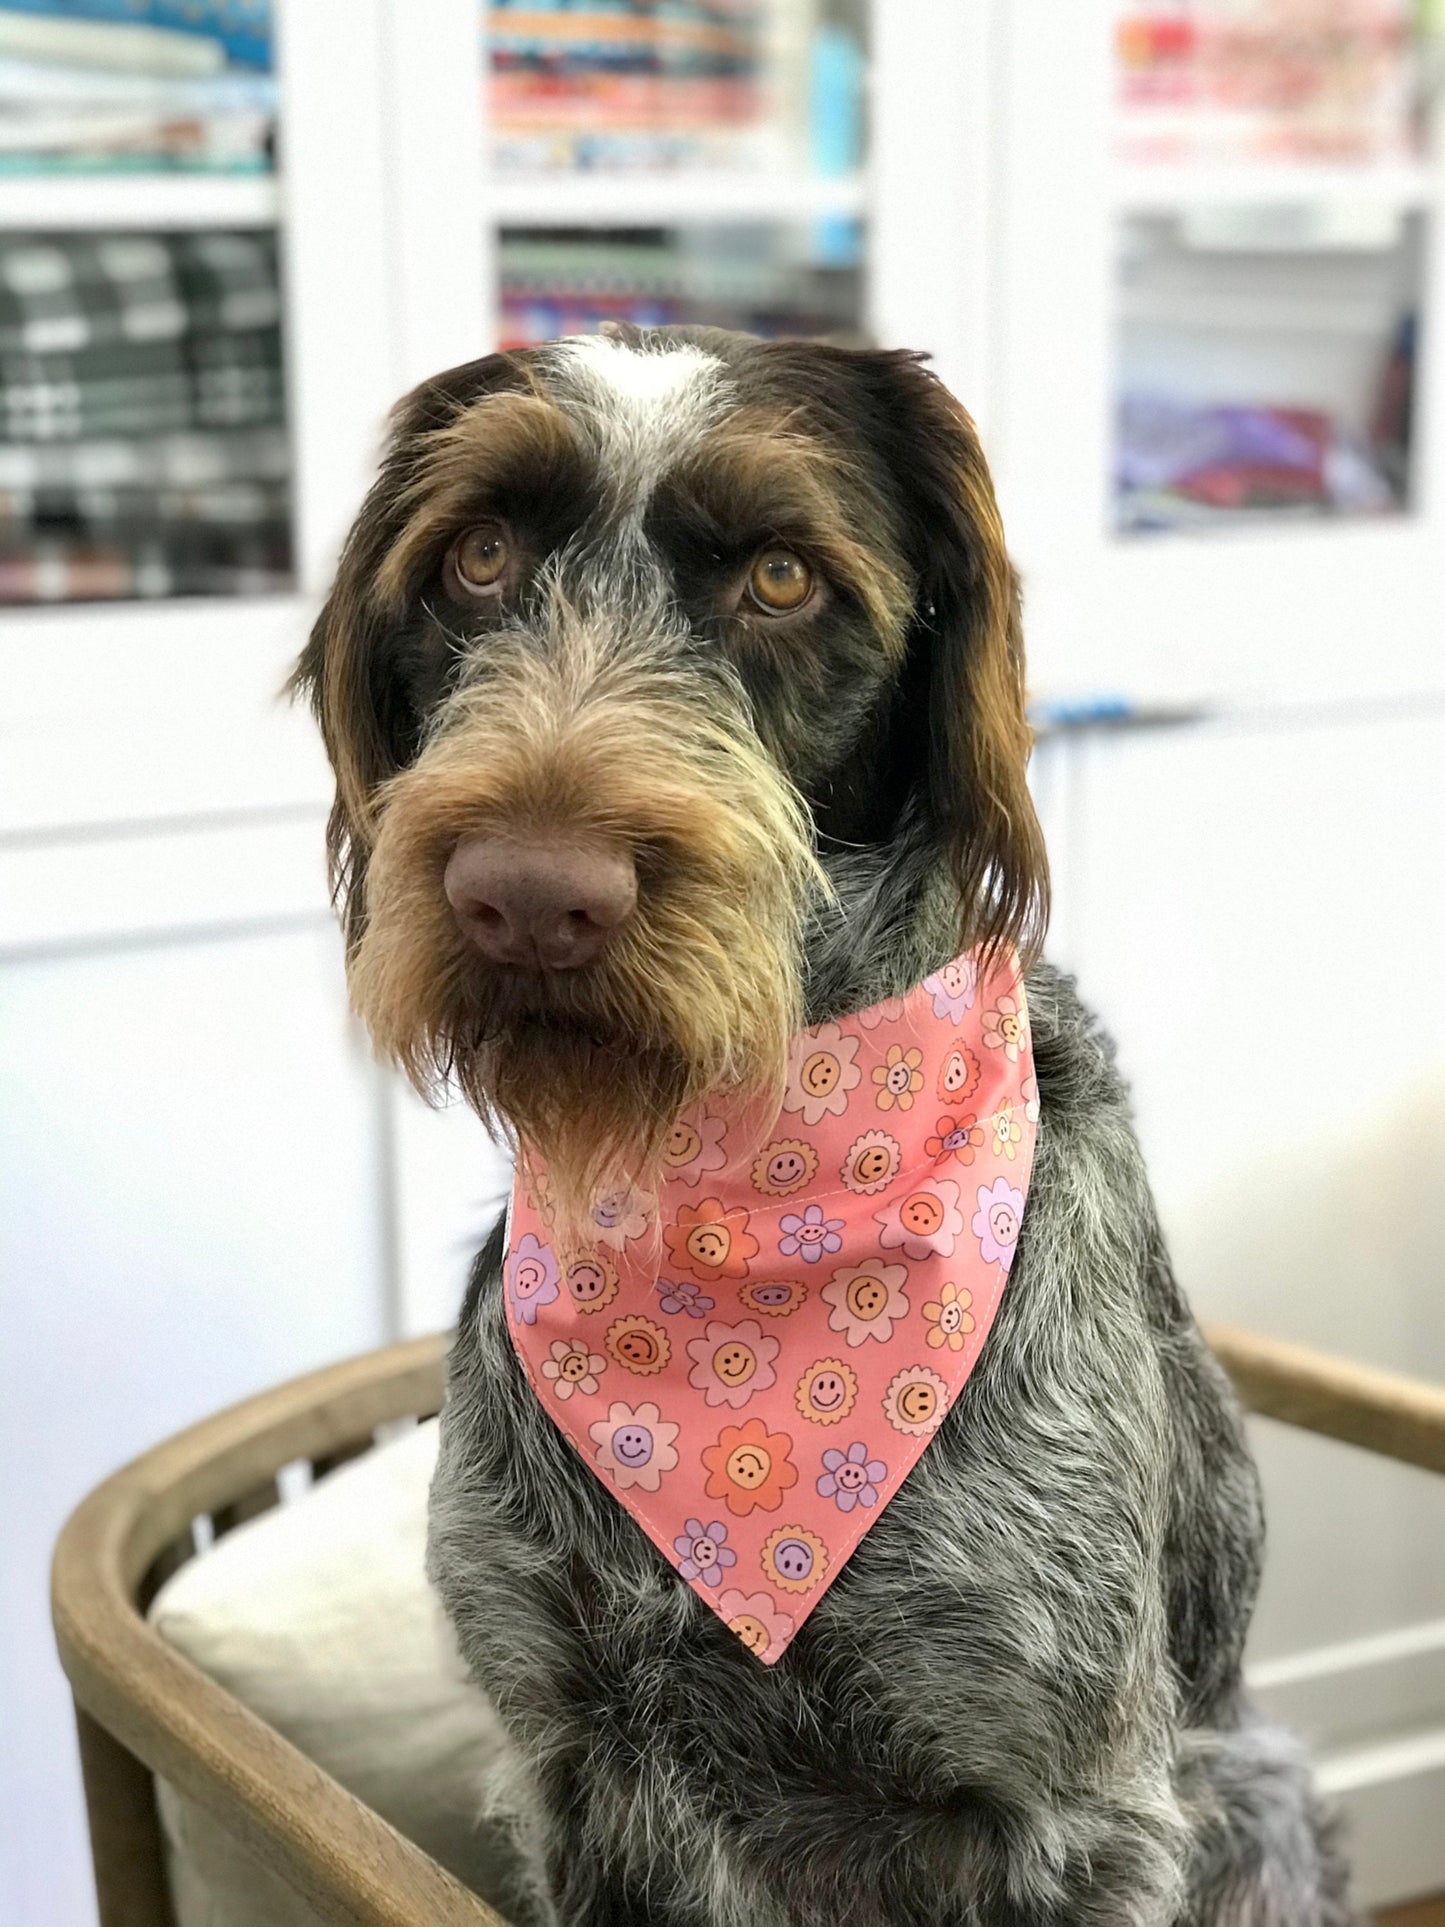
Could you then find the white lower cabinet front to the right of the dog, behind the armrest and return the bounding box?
[1038,713,1445,1898]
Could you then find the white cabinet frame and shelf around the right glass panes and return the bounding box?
[988,0,1445,711]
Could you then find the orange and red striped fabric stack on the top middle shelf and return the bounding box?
[489,0,763,170]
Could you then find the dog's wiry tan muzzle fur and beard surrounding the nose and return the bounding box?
[351,615,823,1243]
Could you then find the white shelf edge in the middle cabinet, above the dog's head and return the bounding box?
[484,172,867,227]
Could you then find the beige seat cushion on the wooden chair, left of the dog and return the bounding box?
[150,1420,530,1927]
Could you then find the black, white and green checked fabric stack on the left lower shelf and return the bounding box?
[0,233,291,603]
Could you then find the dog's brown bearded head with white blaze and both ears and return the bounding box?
[297,317,1046,1206]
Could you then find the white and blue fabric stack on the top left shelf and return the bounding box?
[0,0,276,173]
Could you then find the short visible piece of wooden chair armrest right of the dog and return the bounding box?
[1204,1326,1445,1472]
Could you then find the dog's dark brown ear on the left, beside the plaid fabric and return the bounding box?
[287,355,524,946]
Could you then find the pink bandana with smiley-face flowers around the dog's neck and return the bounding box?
[505,954,1038,1665]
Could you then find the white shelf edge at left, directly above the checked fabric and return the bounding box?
[0,173,279,231]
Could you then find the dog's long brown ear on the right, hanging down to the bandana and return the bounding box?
[879,355,1048,964]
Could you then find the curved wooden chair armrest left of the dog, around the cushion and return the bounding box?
[52,1337,505,1927]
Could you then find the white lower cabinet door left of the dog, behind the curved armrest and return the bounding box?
[0,917,385,1927]
